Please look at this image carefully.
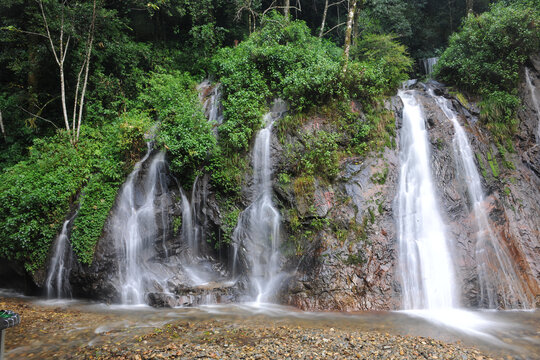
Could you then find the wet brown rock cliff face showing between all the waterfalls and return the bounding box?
[68,67,540,311]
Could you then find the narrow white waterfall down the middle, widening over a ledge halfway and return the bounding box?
[233,100,287,302]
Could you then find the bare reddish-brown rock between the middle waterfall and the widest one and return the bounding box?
[275,98,402,311]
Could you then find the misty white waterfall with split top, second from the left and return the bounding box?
[112,144,166,304]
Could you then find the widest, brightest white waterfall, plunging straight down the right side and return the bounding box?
[397,90,457,310]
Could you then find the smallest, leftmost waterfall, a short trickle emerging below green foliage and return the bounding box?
[45,213,77,298]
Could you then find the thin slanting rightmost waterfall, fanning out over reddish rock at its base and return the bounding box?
[429,90,533,308]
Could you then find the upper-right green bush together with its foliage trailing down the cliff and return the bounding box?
[434,2,540,142]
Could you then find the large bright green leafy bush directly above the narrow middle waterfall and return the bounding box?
[214,14,341,151]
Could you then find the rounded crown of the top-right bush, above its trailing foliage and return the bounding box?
[434,3,540,94]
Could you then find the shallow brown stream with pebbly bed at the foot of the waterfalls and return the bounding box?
[0,293,540,359]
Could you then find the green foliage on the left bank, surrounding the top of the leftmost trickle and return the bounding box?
[0,119,146,271]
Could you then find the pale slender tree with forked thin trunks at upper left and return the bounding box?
[38,0,96,144]
